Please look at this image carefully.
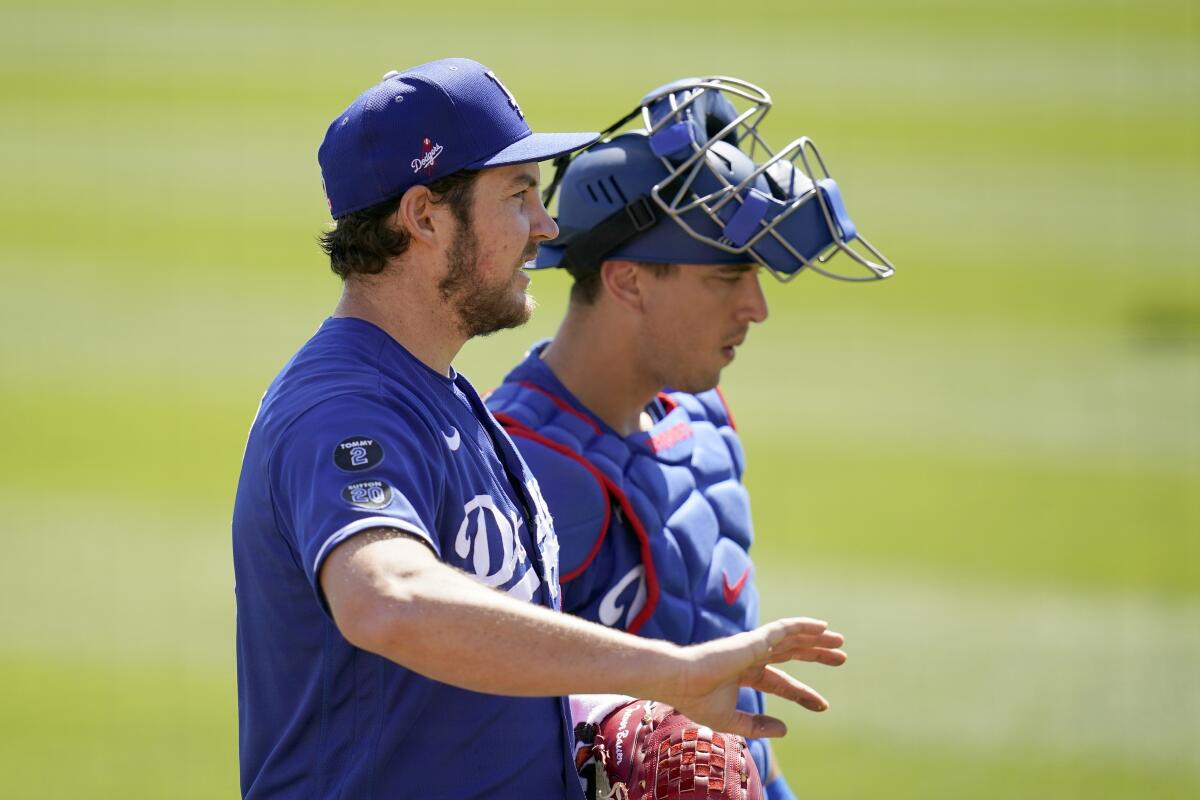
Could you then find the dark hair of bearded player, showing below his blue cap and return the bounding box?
[319,169,480,281]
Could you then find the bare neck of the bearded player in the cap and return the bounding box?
[334,265,467,375]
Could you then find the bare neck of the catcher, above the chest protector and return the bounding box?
[541,306,662,437]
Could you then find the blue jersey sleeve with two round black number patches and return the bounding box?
[269,396,445,596]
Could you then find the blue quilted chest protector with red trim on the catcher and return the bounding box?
[488,367,758,644]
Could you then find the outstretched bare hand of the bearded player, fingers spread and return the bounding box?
[661,616,846,739]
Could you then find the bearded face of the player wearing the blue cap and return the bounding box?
[438,164,558,336]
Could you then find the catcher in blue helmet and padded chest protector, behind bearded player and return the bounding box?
[488,78,892,800]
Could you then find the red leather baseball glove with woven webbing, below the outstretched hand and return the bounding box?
[577,700,763,800]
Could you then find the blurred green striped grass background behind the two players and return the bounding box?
[0,0,1200,799]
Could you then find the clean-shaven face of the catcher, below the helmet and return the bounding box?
[640,264,767,393]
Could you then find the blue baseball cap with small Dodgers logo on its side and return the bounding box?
[317,59,599,219]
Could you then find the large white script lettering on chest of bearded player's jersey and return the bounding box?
[454,494,541,601]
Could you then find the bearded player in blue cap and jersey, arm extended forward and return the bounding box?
[233,59,845,800]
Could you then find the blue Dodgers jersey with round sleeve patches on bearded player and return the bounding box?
[233,319,580,800]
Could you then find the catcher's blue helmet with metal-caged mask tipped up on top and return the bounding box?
[535,77,893,282]
